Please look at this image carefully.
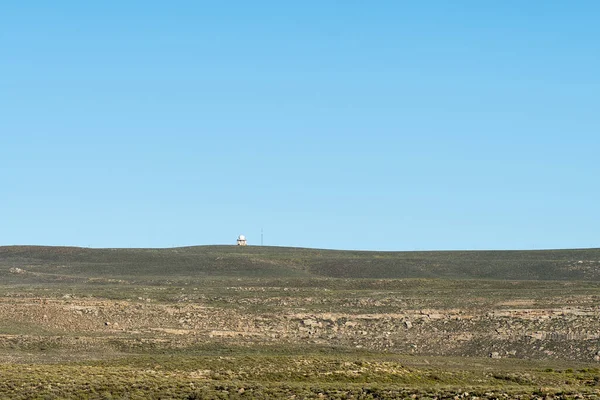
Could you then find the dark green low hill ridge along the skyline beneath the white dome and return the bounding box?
[0,246,600,282]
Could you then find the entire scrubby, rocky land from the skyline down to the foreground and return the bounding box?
[0,246,600,399]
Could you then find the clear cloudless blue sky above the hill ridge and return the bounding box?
[0,0,600,250]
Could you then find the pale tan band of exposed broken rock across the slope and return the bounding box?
[0,296,600,362]
